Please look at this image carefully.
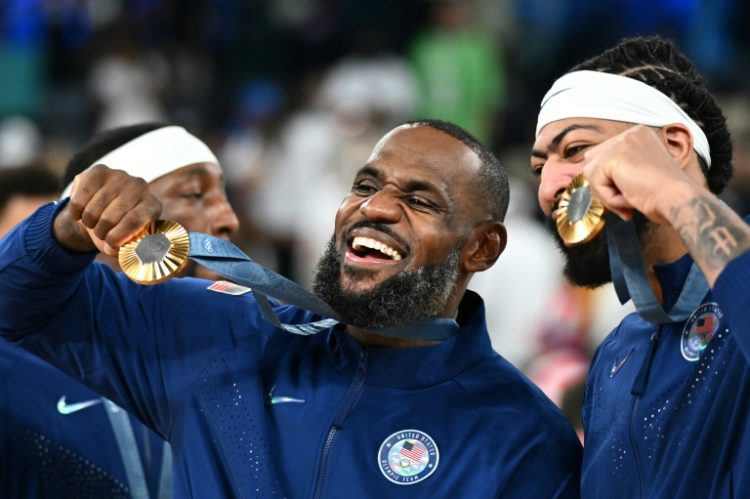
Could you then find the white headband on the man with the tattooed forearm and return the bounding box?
[536,71,711,167]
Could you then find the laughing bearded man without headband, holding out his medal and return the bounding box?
[0,121,581,498]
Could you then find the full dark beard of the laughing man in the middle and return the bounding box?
[313,237,461,329]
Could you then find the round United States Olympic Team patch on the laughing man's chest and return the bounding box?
[378,430,440,485]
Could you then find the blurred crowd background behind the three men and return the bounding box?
[0,0,750,438]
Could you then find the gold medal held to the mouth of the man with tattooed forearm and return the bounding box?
[556,175,606,246]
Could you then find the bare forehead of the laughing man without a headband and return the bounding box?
[368,125,480,185]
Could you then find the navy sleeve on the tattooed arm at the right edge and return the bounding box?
[713,252,750,363]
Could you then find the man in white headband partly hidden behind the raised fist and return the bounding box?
[0,123,238,499]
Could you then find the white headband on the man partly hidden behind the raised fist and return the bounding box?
[62,126,219,198]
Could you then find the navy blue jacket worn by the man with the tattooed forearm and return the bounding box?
[581,223,750,498]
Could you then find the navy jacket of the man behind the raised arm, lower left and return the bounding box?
[0,340,169,499]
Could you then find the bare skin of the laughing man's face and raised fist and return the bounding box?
[54,125,506,347]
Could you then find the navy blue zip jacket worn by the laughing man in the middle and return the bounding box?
[0,207,581,498]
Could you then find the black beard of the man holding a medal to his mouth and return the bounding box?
[547,212,651,289]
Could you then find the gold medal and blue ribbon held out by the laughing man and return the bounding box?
[119,221,459,340]
